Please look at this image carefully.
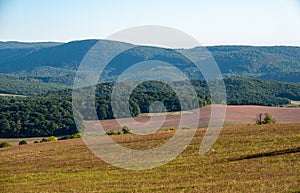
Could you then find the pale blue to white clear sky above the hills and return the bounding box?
[0,0,300,46]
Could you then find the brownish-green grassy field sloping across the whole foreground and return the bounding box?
[0,123,300,192]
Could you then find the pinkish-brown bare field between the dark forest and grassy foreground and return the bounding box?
[89,105,300,130]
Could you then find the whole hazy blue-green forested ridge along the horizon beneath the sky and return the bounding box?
[0,40,300,86]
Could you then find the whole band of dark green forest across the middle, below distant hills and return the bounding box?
[0,78,300,137]
